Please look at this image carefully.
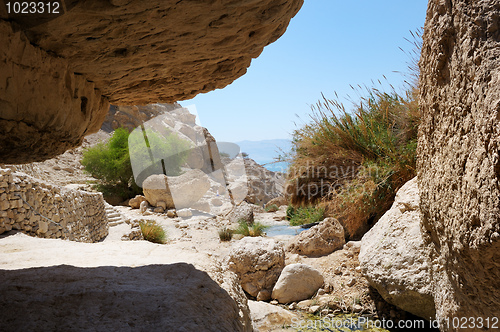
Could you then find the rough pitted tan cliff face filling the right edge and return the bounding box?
[417,0,500,330]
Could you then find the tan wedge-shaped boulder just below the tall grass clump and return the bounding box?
[286,218,345,256]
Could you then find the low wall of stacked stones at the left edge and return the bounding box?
[0,168,108,242]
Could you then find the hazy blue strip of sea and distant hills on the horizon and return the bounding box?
[235,139,292,171]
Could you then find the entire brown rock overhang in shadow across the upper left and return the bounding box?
[0,0,303,163]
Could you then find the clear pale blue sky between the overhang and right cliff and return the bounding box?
[181,0,427,142]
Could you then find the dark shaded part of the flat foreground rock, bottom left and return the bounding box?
[0,263,250,332]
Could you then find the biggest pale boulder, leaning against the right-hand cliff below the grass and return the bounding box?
[359,178,436,319]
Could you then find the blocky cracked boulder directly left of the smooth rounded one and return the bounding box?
[226,237,285,300]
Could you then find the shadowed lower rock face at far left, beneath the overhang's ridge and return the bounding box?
[0,20,109,163]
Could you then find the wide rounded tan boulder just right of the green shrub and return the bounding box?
[142,169,210,209]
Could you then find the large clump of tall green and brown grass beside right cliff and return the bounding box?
[288,88,420,239]
